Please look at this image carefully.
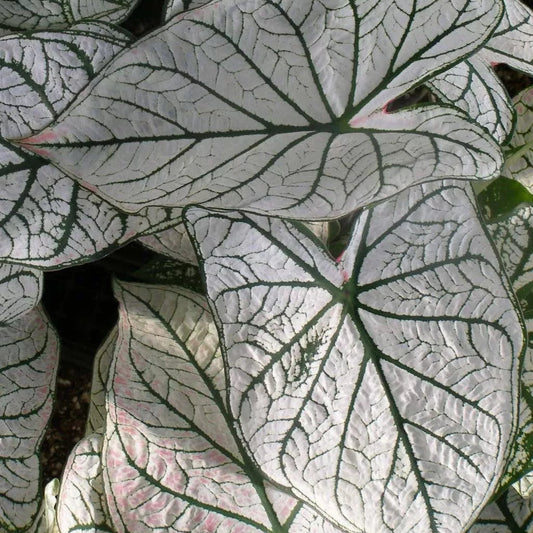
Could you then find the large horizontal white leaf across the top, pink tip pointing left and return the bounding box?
[21,0,502,220]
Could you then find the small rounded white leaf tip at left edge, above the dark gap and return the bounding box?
[0,263,43,326]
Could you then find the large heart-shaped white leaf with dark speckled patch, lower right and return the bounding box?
[184,182,523,533]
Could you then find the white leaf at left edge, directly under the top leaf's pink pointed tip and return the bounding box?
[0,139,185,268]
